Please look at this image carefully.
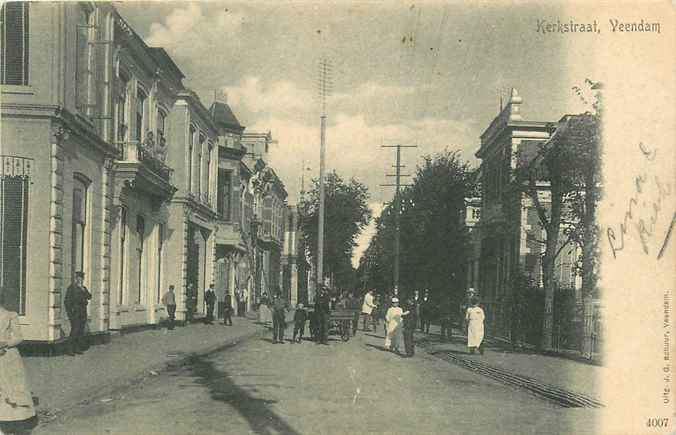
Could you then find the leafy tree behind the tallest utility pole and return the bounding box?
[299,171,371,288]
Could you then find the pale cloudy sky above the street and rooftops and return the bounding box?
[116,1,591,265]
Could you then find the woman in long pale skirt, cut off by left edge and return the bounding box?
[0,300,35,434]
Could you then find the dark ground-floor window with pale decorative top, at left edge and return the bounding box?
[0,157,32,315]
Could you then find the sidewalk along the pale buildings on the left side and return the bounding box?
[23,312,293,419]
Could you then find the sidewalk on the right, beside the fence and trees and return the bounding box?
[416,325,606,406]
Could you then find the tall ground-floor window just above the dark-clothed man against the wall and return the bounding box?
[70,175,89,281]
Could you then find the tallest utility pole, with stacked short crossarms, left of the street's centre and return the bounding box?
[317,59,331,286]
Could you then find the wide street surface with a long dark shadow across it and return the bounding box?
[34,330,598,434]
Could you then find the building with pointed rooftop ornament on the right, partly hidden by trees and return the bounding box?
[468,89,578,338]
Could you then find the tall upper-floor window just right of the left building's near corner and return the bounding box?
[75,6,96,116]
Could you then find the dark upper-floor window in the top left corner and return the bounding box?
[0,2,29,86]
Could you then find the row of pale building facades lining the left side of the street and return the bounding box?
[0,2,286,343]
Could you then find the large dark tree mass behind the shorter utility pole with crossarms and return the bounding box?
[359,151,473,306]
